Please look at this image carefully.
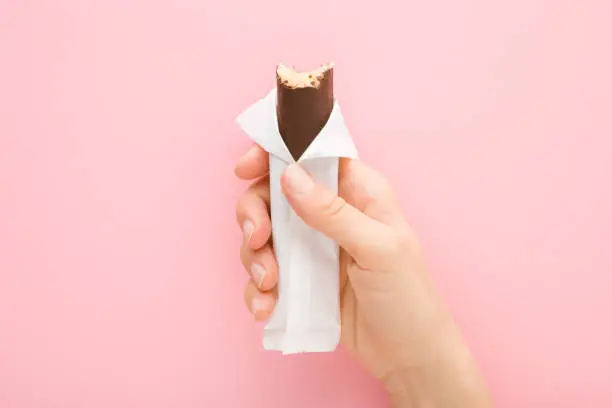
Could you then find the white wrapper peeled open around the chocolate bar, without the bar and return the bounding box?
[237,89,357,354]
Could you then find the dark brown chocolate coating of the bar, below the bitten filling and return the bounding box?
[276,68,334,161]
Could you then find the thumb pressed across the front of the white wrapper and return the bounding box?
[281,164,391,267]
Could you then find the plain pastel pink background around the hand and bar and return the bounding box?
[0,0,612,408]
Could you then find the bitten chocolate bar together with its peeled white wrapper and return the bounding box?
[237,64,358,354]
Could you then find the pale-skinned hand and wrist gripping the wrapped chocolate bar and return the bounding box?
[235,146,493,408]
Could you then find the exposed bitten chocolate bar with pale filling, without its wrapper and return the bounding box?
[276,64,334,161]
